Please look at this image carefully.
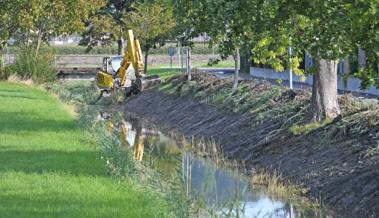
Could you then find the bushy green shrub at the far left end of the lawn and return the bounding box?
[6,48,56,83]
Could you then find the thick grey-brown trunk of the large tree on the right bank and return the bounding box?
[311,59,341,121]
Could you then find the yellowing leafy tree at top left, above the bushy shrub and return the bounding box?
[10,0,103,55]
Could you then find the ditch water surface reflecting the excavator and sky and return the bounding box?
[100,113,327,218]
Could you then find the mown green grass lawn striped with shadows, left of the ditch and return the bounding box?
[0,82,168,218]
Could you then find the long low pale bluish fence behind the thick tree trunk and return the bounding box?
[250,67,379,96]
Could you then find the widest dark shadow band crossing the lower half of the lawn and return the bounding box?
[0,150,106,177]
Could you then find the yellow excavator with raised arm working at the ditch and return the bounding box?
[96,30,161,99]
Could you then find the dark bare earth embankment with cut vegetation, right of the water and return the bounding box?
[125,74,379,217]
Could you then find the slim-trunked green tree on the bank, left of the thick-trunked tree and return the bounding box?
[177,0,249,92]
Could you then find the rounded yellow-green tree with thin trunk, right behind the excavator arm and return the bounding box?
[127,1,175,72]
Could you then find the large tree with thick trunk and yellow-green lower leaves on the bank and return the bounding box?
[248,0,364,121]
